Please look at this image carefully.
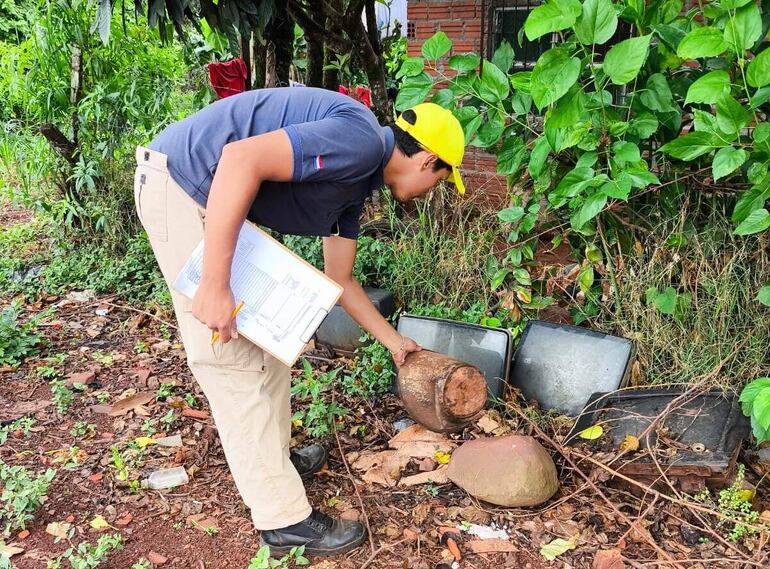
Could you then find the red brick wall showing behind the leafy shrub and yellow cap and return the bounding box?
[407,0,506,205]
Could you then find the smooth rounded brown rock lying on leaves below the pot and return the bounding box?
[447,435,559,506]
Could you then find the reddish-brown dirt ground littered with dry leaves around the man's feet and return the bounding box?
[0,297,547,569]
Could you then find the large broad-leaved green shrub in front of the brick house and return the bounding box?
[396,0,770,324]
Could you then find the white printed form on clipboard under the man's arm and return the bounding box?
[174,222,342,366]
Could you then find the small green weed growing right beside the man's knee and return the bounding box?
[291,358,348,437]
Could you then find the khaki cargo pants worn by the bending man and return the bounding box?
[134,147,311,530]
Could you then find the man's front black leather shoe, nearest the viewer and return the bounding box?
[260,510,366,557]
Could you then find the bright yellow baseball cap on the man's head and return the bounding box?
[396,103,465,195]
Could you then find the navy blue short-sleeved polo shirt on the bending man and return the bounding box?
[150,87,394,239]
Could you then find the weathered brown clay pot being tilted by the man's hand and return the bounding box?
[396,350,487,433]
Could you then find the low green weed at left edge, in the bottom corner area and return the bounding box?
[0,460,56,535]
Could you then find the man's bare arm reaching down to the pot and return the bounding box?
[323,237,422,365]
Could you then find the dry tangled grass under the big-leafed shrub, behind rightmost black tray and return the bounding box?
[601,204,770,387]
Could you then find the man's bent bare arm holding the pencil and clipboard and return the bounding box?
[192,130,294,342]
